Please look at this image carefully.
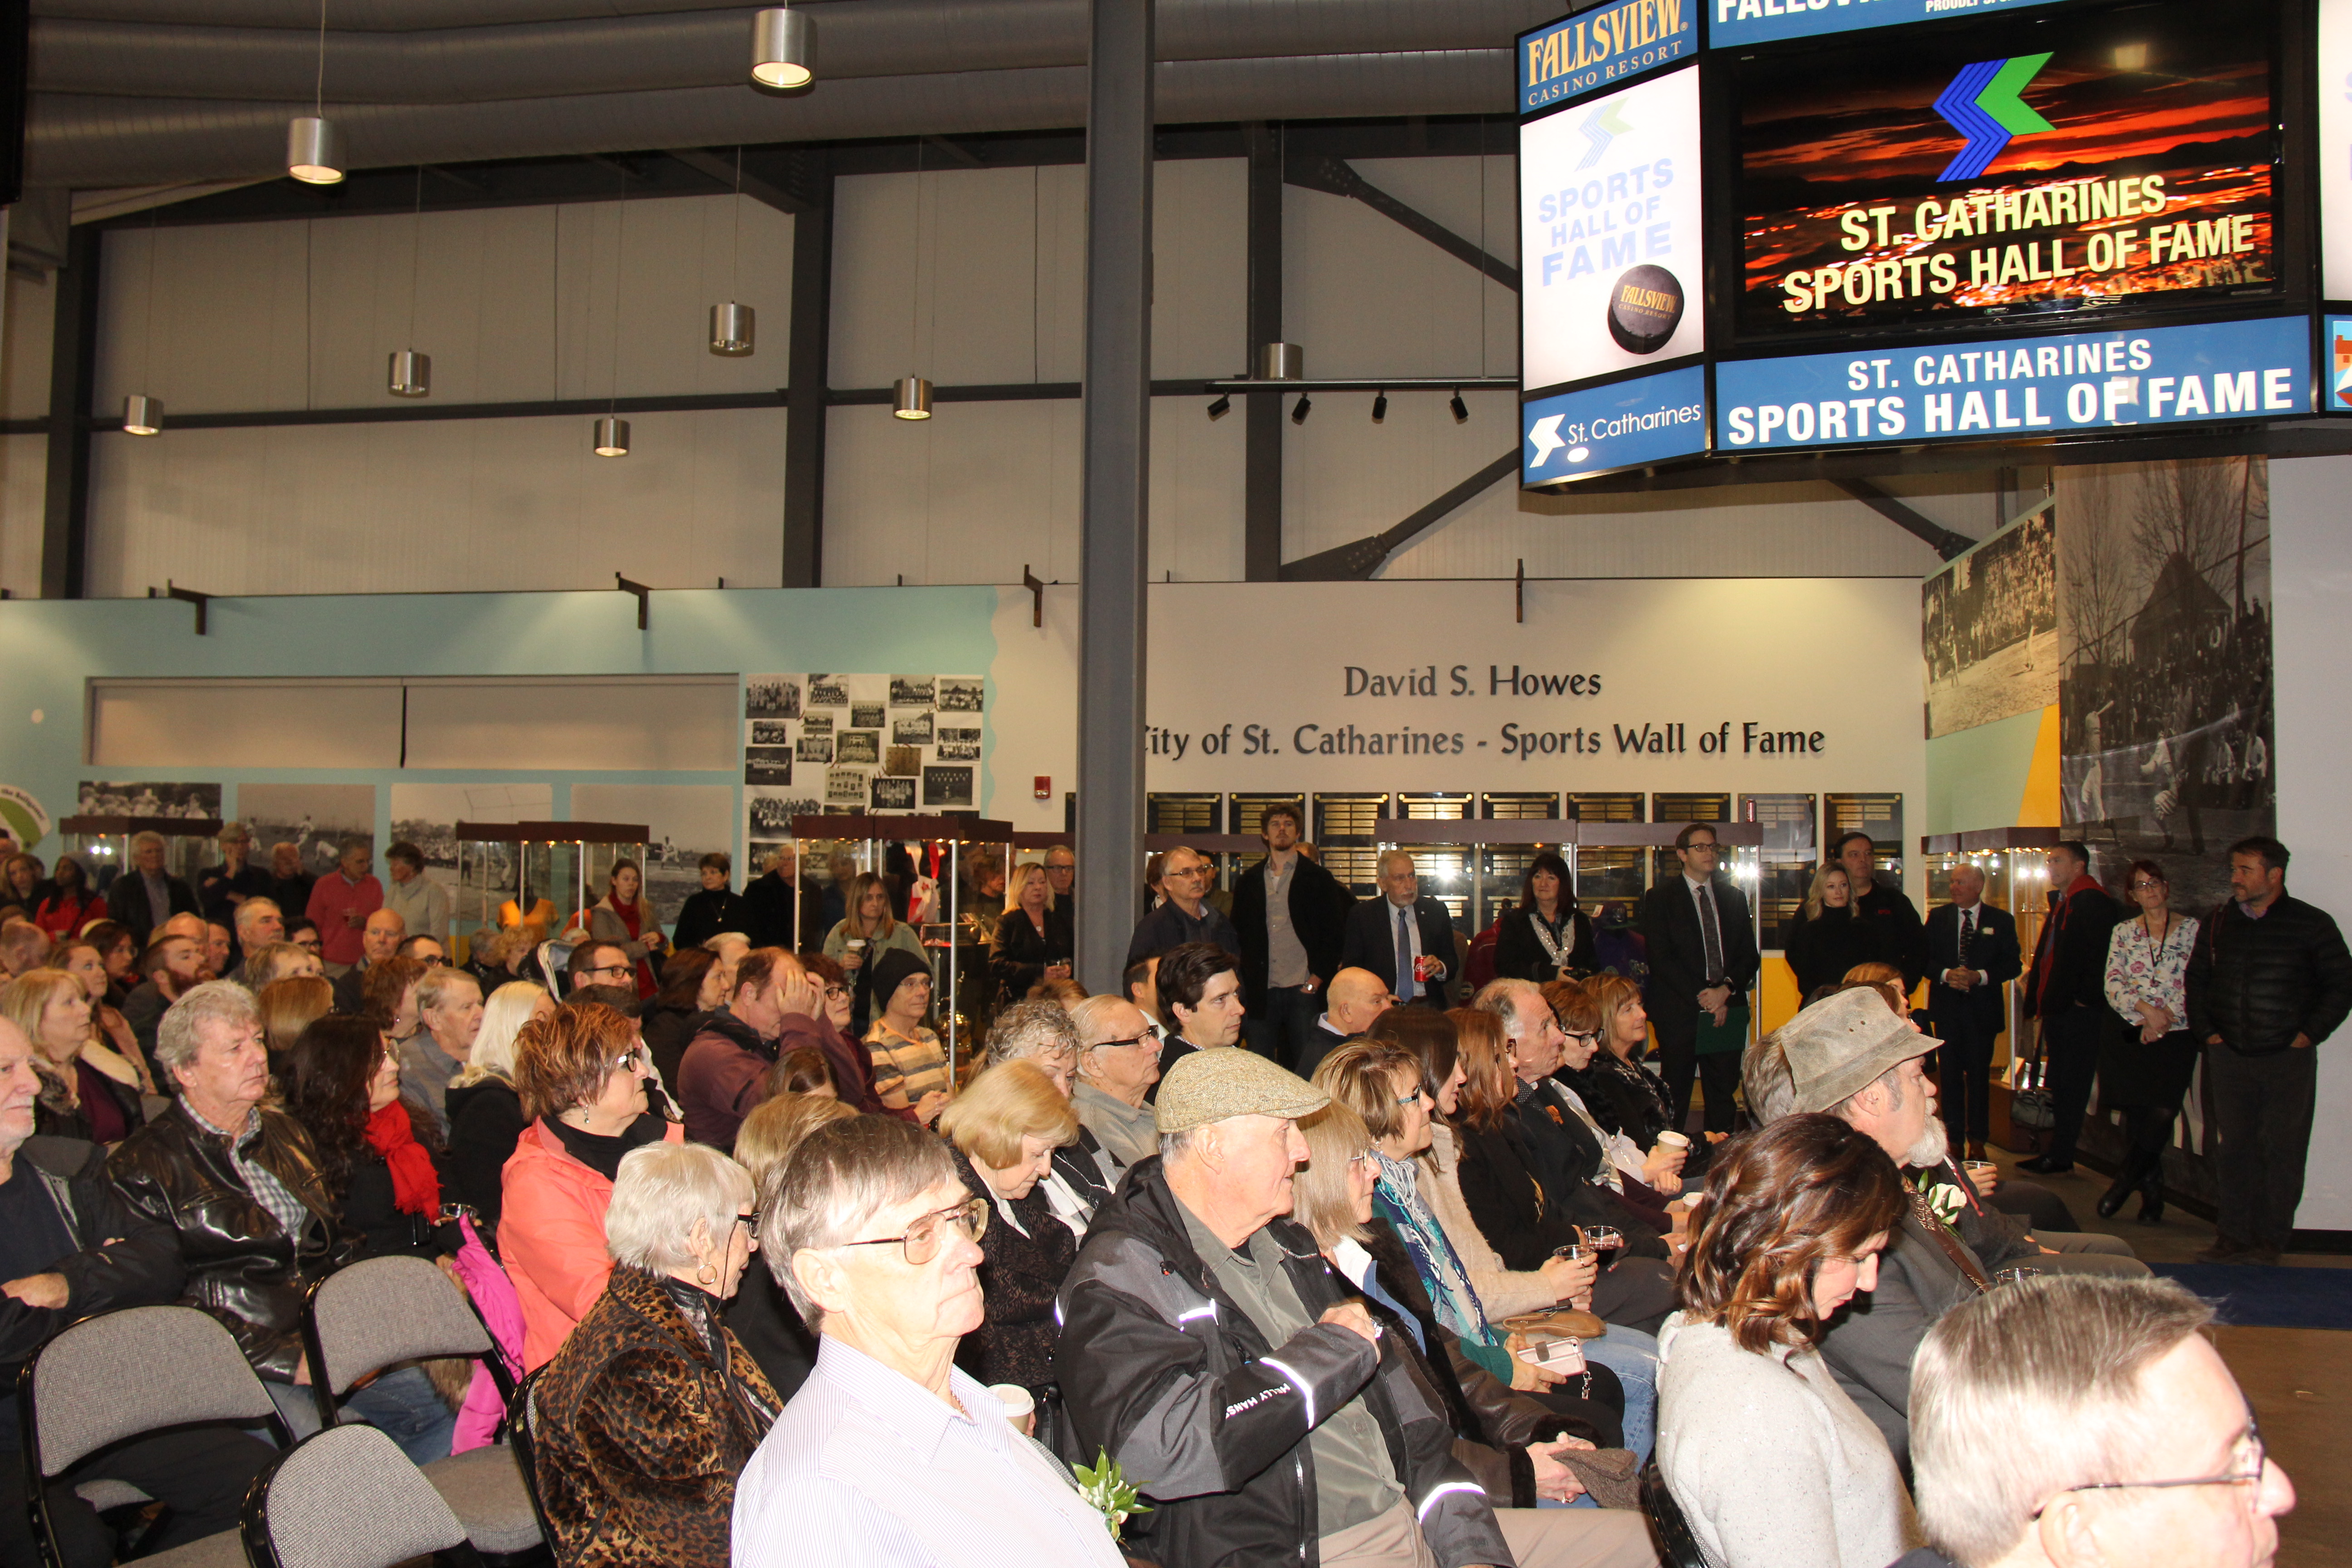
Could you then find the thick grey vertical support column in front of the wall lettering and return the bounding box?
[1077,0,1152,995]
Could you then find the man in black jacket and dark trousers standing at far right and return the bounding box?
[2187,837,2352,1262]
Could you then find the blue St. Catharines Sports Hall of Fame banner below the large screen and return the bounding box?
[1715,315,2312,451]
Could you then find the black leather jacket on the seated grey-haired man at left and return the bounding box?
[106,1100,343,1382]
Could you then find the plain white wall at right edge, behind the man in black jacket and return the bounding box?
[2270,458,2352,1230]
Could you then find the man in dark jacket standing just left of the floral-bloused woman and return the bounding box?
[2018,839,2124,1176]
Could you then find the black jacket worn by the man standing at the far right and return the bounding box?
[2187,893,2352,1055]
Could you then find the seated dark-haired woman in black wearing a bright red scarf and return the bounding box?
[287,1013,459,1465]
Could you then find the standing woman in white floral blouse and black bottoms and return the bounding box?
[2098,860,2197,1225]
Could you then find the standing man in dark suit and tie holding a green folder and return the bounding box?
[1635,823,1759,1133]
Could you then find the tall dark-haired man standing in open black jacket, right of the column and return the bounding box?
[1232,802,1355,1065]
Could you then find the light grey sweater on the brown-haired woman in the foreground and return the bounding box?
[1658,1312,1919,1568]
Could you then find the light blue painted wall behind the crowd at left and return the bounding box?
[0,588,997,853]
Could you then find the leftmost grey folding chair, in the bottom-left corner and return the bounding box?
[16,1307,287,1568]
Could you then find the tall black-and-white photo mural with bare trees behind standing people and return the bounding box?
[2058,456,2277,912]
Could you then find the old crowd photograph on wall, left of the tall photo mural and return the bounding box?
[1919,505,2058,740]
